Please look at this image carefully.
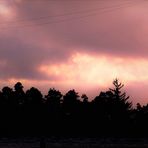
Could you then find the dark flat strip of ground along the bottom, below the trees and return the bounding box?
[0,137,148,148]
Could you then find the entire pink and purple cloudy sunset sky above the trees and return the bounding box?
[0,0,148,104]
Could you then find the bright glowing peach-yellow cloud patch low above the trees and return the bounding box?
[39,53,148,87]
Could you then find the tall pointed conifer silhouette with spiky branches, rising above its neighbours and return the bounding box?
[109,79,132,134]
